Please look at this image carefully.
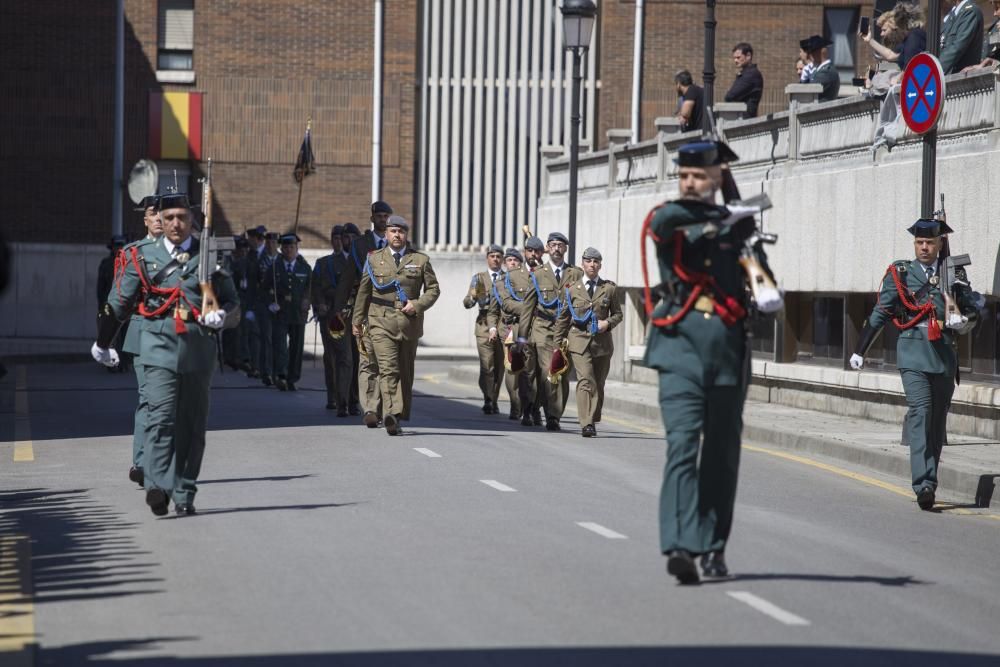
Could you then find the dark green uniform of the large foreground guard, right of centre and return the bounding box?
[645,201,750,555]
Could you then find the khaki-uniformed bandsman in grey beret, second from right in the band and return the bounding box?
[531,232,583,431]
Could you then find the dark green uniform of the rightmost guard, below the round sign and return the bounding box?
[859,260,976,496]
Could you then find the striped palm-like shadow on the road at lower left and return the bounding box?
[0,489,163,604]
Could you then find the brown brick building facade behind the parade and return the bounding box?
[0,0,992,247]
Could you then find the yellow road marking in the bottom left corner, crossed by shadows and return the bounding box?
[0,535,36,667]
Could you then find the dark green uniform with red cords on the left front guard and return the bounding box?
[108,238,239,505]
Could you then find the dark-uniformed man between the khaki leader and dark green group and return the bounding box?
[312,225,354,417]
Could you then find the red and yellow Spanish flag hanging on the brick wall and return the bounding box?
[149,91,204,160]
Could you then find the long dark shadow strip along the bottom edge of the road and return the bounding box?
[31,639,997,667]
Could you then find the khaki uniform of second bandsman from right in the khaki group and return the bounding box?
[531,262,583,419]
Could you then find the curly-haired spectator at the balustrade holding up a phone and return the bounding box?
[861,2,927,150]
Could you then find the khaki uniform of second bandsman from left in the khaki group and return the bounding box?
[490,266,538,414]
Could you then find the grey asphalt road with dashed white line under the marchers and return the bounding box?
[0,362,1000,667]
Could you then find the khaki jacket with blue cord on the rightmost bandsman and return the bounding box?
[559,277,622,357]
